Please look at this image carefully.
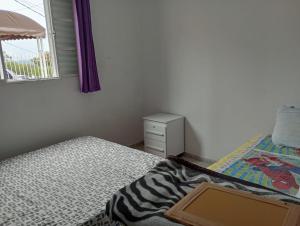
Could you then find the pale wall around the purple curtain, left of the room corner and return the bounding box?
[0,0,143,159]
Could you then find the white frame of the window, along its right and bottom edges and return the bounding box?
[0,0,61,84]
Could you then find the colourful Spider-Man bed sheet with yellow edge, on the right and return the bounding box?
[209,135,300,198]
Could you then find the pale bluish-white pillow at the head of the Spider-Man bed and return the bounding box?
[272,106,300,148]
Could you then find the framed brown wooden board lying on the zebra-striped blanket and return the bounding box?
[165,183,300,226]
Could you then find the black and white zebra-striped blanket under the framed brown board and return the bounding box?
[106,158,300,226]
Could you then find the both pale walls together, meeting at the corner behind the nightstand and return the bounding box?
[0,0,300,162]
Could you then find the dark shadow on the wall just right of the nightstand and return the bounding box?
[185,118,202,156]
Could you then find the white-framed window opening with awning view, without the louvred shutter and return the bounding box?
[0,0,58,81]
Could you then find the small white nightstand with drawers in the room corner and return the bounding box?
[144,113,184,158]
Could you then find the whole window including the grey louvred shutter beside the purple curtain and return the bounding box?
[0,0,78,82]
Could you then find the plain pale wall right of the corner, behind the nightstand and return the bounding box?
[144,0,300,159]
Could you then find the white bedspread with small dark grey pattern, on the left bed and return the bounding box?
[0,137,162,226]
